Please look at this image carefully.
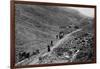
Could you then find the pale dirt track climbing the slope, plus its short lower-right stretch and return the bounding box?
[16,29,82,65]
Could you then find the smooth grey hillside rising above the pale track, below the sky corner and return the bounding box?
[15,4,93,63]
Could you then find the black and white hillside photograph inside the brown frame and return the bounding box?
[15,4,95,66]
